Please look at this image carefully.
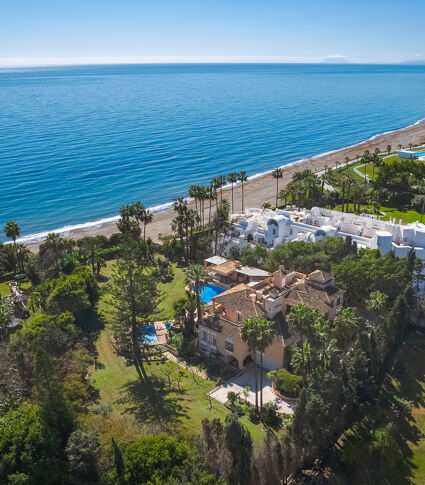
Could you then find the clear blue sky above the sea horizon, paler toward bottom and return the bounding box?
[0,0,425,65]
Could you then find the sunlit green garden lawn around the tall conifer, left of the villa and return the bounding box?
[91,262,265,442]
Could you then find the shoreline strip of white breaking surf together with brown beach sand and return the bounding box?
[21,119,425,252]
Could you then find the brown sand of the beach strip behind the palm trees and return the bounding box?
[27,118,425,252]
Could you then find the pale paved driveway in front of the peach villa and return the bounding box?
[209,369,296,414]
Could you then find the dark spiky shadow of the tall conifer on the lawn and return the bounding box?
[118,376,185,429]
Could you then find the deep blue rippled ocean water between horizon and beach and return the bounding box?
[0,64,425,239]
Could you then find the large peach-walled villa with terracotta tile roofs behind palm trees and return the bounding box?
[199,265,343,370]
